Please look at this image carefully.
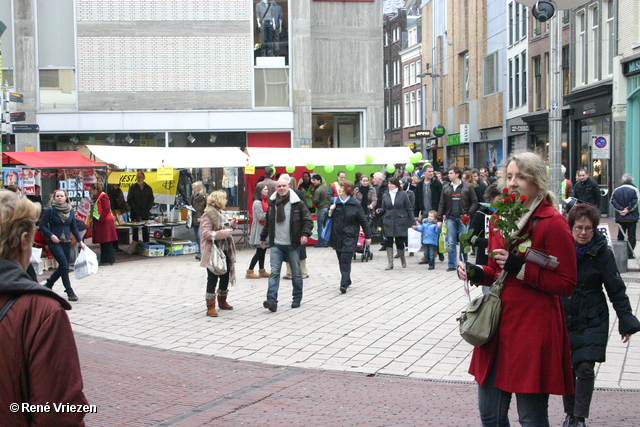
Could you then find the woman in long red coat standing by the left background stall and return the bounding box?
[89,183,118,265]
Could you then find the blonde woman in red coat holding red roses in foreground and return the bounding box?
[458,153,577,426]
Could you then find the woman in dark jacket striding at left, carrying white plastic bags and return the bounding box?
[39,189,85,301]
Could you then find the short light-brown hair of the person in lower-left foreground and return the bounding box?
[0,190,40,260]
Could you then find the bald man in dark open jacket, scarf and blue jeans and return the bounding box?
[260,177,313,312]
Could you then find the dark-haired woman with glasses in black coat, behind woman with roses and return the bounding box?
[562,203,640,427]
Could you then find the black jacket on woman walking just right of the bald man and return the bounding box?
[329,197,371,252]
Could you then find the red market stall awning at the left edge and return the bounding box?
[2,151,107,169]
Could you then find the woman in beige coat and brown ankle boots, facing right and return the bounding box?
[200,190,237,317]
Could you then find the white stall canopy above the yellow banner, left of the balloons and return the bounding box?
[87,145,249,169]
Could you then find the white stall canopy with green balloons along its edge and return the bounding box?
[247,147,413,167]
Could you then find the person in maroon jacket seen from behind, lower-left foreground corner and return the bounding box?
[0,190,89,427]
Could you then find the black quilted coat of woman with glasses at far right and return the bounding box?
[561,232,640,366]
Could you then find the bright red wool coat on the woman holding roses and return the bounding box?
[469,200,577,395]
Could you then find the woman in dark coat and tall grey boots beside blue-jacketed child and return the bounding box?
[376,177,415,270]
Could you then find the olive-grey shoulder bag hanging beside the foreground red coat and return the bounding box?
[456,270,506,347]
